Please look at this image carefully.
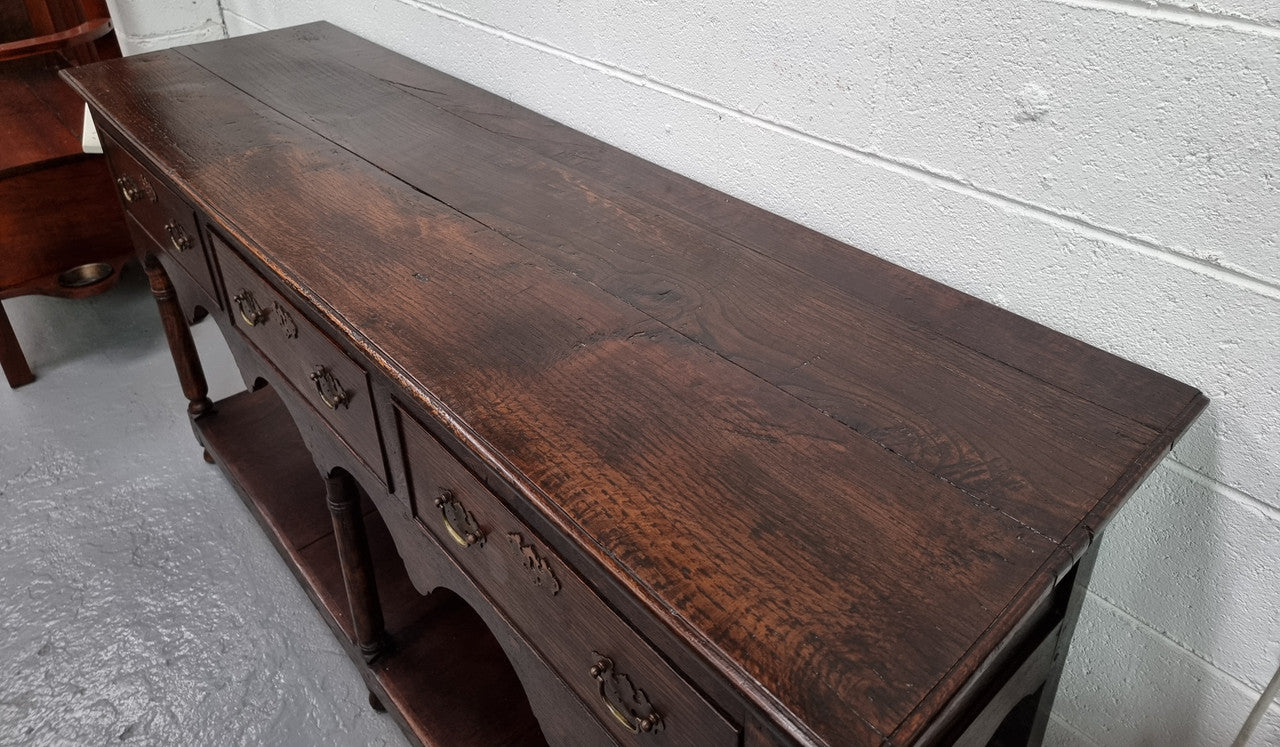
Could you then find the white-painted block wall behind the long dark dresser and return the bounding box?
[132,0,1280,744]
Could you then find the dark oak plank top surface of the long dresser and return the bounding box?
[69,23,1206,744]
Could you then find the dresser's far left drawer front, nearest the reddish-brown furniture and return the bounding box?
[101,134,219,303]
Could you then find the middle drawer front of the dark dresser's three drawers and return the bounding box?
[210,234,385,481]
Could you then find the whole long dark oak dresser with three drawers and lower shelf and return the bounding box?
[67,23,1206,747]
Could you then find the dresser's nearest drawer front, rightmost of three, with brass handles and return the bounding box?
[397,408,737,747]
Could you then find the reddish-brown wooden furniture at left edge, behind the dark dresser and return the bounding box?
[0,0,133,388]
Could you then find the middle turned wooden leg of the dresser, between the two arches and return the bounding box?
[325,471,385,661]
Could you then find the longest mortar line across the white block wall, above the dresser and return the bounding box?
[398,0,1280,301]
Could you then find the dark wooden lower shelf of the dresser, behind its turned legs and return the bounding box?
[195,388,547,747]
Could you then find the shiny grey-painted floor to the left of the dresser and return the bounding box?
[0,266,404,746]
